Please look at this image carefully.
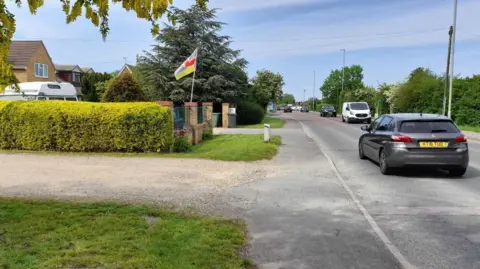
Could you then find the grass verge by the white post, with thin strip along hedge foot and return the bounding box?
[0,135,282,161]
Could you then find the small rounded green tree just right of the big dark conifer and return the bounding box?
[249,69,285,108]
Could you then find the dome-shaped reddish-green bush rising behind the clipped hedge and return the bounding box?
[102,74,145,102]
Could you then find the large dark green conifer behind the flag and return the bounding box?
[137,5,248,102]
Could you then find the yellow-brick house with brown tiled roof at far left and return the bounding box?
[8,41,55,82]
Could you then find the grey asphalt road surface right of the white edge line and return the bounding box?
[283,112,480,269]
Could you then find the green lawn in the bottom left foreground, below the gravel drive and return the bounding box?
[0,198,251,269]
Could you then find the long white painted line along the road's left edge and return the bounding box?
[298,121,415,269]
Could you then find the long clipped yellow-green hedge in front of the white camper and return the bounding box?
[0,101,173,152]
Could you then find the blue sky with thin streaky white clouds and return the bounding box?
[7,0,480,100]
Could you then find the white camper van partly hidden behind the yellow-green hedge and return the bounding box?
[0,82,78,101]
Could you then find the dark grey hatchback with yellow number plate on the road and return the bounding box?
[358,113,469,177]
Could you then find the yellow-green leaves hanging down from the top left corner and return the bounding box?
[0,0,208,89]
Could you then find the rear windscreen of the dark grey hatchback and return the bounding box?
[400,120,460,134]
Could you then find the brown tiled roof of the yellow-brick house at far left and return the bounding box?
[8,40,50,69]
